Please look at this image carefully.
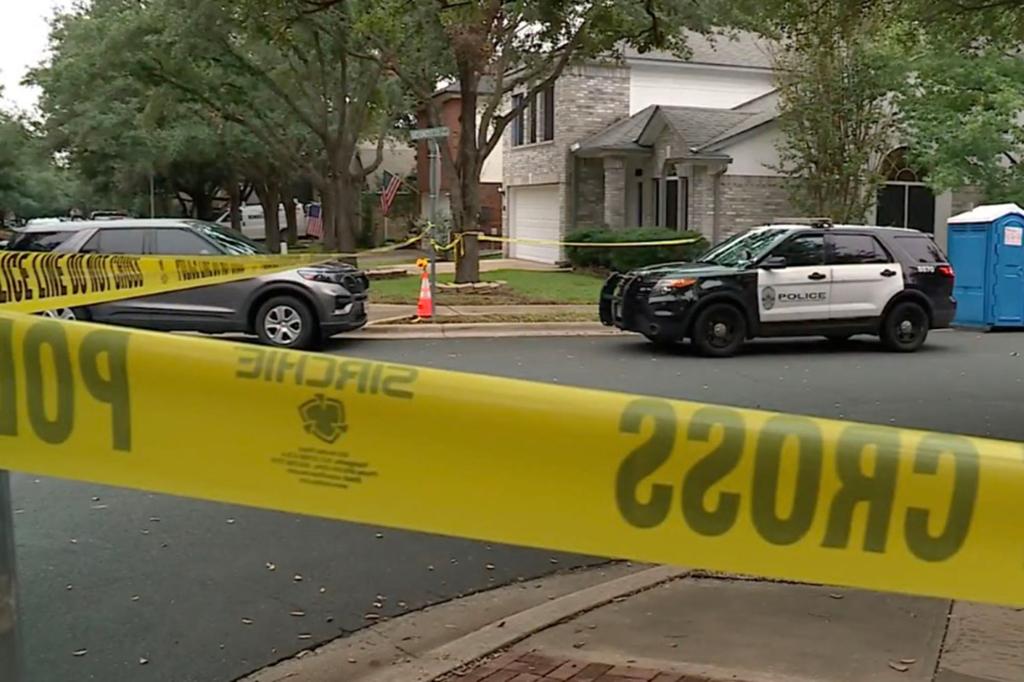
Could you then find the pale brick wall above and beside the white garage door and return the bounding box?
[503,65,630,235]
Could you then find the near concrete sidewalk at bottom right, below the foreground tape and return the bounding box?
[456,579,1024,682]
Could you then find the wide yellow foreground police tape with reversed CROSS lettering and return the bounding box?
[0,305,1024,605]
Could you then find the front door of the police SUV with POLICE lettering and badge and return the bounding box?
[758,232,831,324]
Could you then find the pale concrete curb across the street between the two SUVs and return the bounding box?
[356,317,622,340]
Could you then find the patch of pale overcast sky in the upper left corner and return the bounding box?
[0,0,71,112]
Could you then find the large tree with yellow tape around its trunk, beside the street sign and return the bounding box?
[352,0,719,282]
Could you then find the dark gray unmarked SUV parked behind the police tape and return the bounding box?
[7,219,370,348]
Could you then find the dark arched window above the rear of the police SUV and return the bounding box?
[876,146,935,232]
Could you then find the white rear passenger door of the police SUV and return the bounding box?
[826,233,905,319]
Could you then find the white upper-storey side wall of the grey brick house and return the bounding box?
[630,60,773,115]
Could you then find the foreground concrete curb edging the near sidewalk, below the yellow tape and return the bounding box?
[360,566,690,682]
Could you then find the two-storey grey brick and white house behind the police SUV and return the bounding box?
[504,34,974,262]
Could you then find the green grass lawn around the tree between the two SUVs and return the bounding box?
[370,270,603,305]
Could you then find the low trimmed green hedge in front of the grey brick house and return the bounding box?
[565,227,708,272]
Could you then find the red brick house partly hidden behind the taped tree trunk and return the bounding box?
[416,84,504,235]
